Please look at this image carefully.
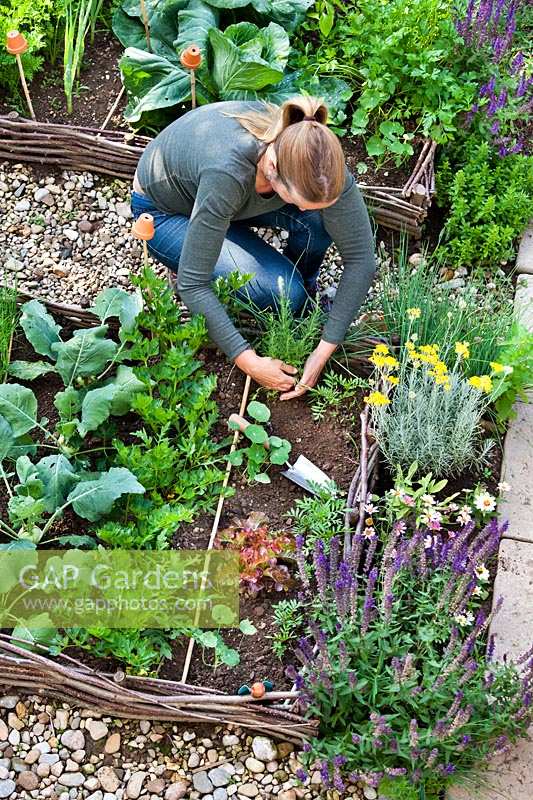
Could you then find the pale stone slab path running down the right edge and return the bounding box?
[447,220,533,800]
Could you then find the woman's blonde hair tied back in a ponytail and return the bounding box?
[229,95,345,203]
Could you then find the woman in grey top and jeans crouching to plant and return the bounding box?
[131,97,375,400]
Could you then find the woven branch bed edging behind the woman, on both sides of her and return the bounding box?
[0,112,436,238]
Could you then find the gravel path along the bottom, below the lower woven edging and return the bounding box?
[0,695,370,800]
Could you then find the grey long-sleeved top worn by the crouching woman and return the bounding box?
[137,102,375,359]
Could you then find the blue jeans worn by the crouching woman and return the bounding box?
[131,192,332,312]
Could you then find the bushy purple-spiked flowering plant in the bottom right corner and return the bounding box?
[289,519,533,800]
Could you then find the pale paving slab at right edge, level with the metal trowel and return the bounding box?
[500,403,533,544]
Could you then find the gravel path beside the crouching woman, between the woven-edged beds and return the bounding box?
[0,162,341,308]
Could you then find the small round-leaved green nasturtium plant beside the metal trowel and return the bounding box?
[228,400,292,483]
